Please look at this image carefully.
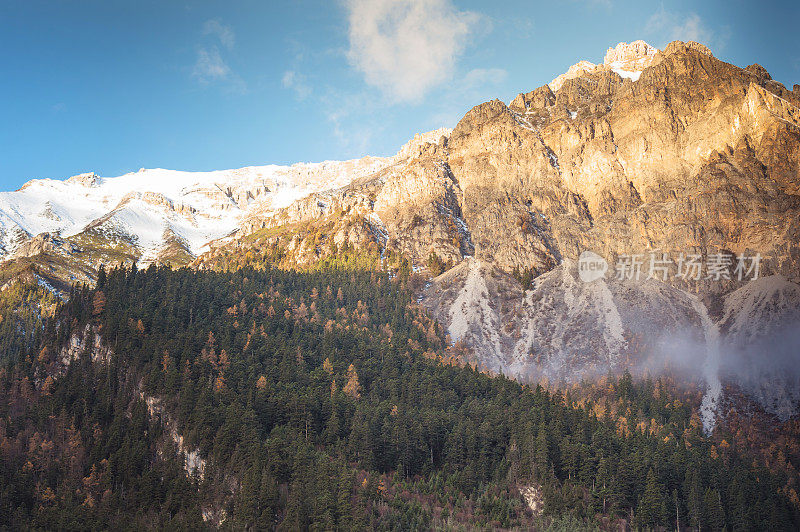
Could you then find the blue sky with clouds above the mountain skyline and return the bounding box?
[0,0,800,190]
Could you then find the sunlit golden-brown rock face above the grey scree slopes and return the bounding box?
[244,41,800,291]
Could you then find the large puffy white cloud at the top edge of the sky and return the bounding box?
[345,0,481,102]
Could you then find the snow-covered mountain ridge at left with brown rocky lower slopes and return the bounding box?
[0,130,445,287]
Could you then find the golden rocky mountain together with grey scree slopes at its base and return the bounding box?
[195,41,800,420]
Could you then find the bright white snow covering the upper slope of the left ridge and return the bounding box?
[0,150,438,262]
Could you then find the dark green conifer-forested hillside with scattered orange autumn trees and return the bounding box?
[0,254,800,530]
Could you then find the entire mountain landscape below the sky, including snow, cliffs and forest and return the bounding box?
[0,41,800,530]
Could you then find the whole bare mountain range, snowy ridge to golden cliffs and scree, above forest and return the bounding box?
[0,41,800,418]
